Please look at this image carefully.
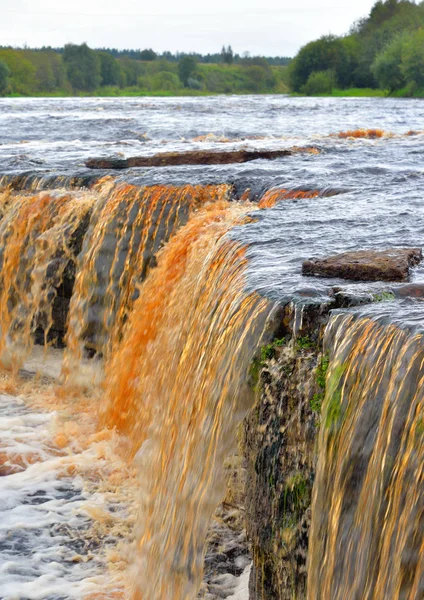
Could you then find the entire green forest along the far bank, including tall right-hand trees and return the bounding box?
[0,0,424,96]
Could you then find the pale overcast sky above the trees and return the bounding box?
[0,0,375,56]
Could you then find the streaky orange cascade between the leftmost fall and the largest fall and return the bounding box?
[67,184,229,368]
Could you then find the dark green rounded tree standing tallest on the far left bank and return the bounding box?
[63,44,102,92]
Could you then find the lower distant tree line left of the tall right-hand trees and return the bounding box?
[0,44,290,96]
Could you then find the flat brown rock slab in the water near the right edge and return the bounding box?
[302,248,423,281]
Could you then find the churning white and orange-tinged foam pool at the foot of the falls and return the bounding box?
[0,368,137,600]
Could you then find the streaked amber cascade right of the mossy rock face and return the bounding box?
[308,315,424,600]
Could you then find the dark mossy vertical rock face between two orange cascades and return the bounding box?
[243,332,325,600]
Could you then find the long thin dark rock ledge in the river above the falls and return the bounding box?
[85,150,292,169]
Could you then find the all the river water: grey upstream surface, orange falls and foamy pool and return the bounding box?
[0,96,424,600]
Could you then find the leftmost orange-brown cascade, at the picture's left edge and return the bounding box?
[0,191,95,369]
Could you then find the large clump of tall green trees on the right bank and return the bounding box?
[289,0,424,96]
